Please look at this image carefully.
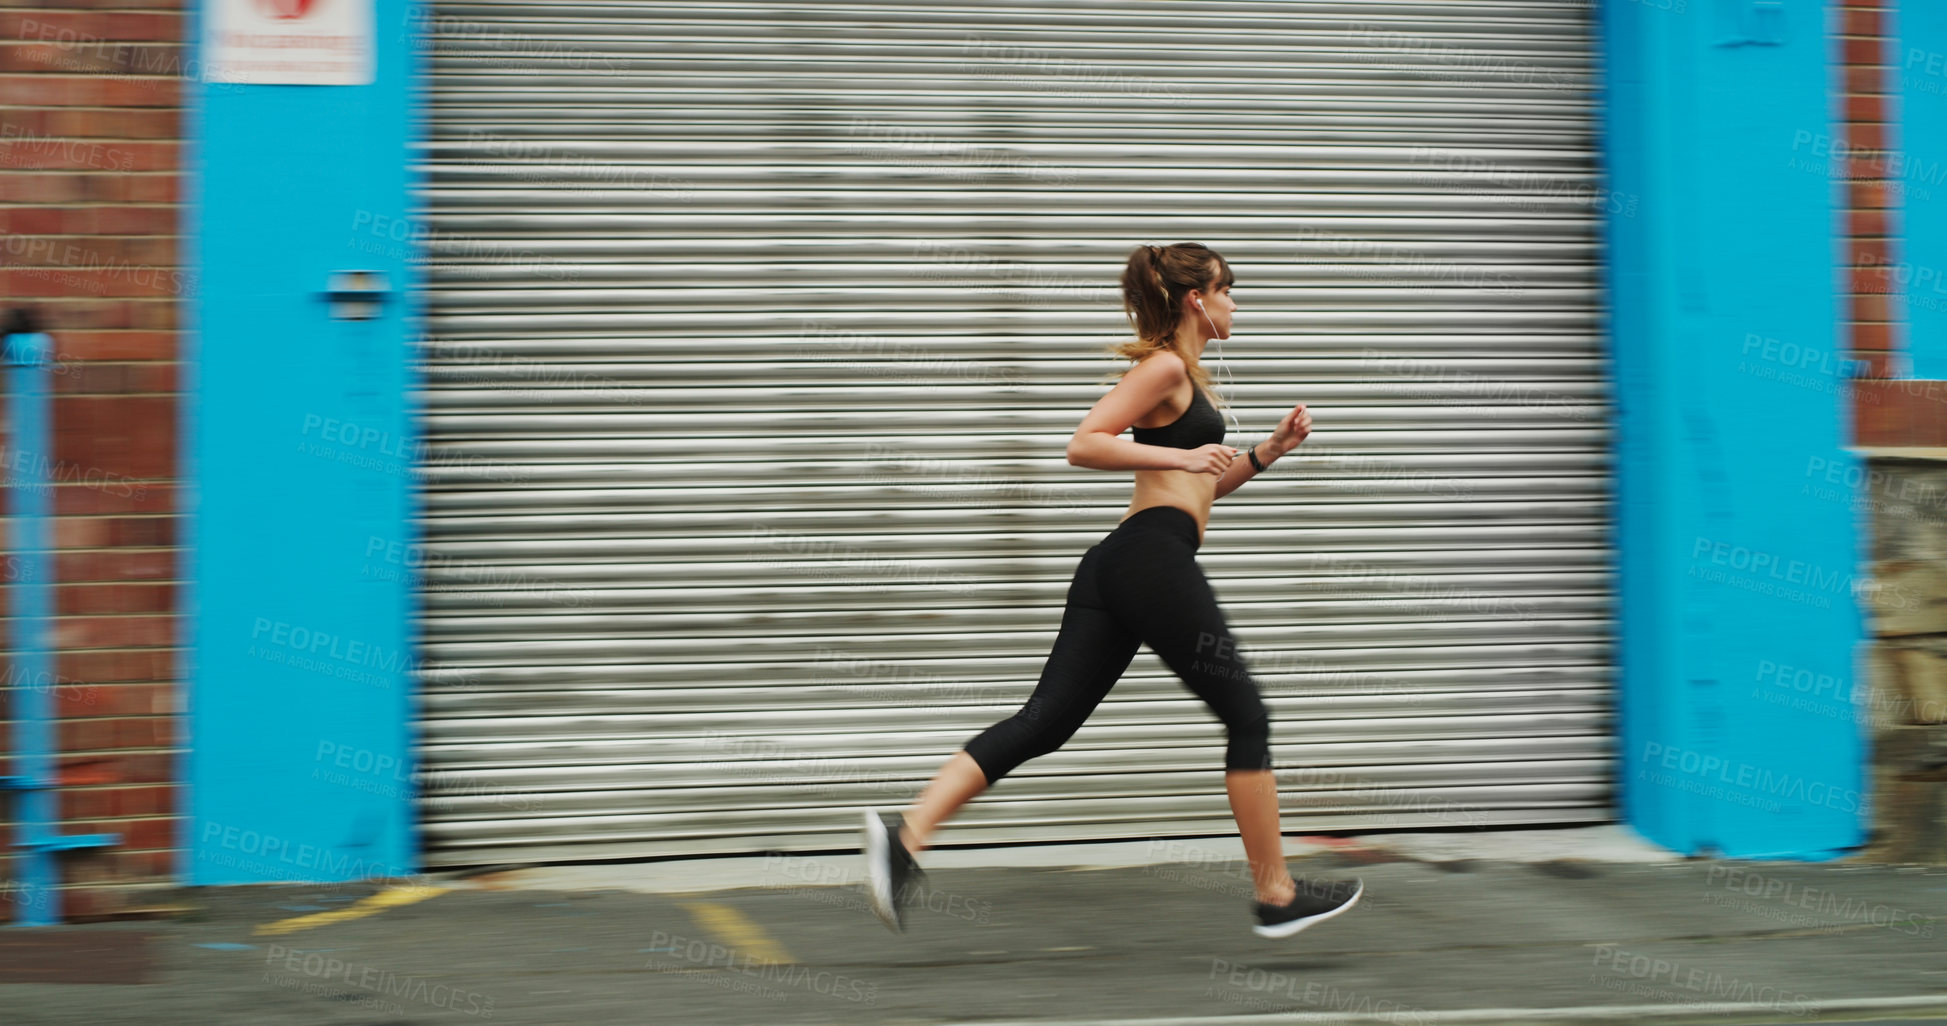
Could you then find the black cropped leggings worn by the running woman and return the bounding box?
[966,506,1271,785]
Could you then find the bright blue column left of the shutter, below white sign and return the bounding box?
[181,0,421,884]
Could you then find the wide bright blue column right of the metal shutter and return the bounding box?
[1600,0,1869,859]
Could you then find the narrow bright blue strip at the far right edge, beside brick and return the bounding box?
[1887,0,1947,380]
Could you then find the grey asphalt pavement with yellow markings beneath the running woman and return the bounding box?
[11,827,1947,1026]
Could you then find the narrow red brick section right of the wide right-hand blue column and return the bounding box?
[1834,0,1947,438]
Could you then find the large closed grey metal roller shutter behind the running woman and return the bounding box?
[413,0,1622,866]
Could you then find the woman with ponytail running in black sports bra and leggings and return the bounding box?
[864,241,1365,936]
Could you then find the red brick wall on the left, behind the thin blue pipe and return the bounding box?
[0,0,183,917]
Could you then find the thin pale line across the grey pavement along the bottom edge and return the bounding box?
[956,993,1947,1026]
